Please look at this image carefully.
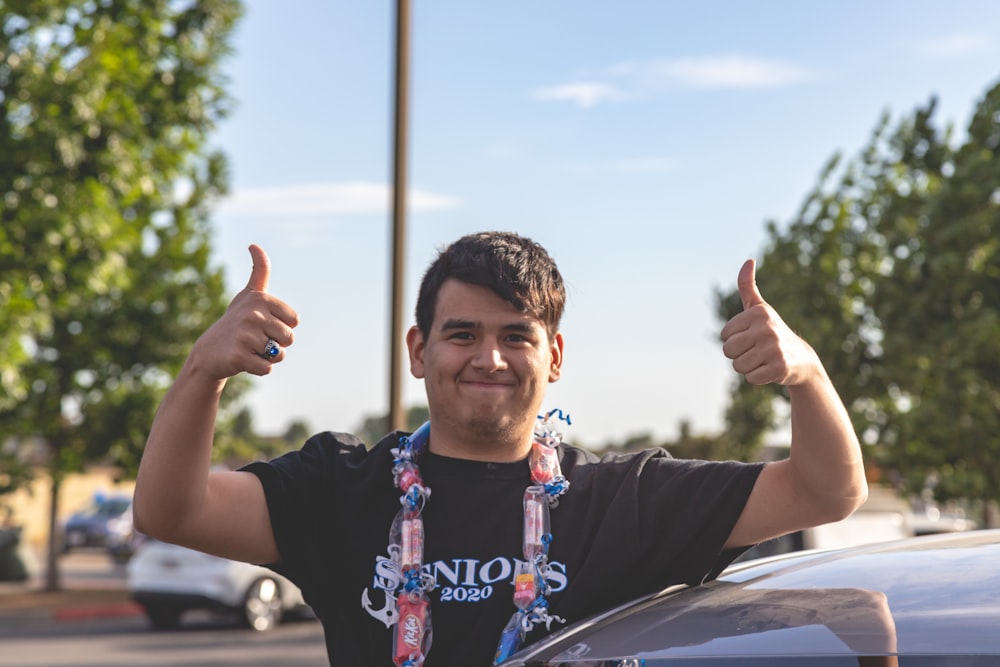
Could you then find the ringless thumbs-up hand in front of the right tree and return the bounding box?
[722,259,822,385]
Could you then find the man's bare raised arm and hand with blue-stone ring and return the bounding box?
[132,246,298,563]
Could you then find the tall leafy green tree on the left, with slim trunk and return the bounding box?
[0,0,241,589]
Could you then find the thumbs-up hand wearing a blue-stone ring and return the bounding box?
[189,245,299,380]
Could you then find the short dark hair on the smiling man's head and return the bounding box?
[416,232,566,339]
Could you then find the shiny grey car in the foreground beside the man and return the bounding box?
[501,530,1000,667]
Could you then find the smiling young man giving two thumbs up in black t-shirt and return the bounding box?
[134,232,867,667]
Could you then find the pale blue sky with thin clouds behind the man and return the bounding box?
[213,0,1000,445]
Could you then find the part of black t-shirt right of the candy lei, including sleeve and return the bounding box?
[554,448,762,594]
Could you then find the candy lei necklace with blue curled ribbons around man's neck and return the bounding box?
[389,410,571,667]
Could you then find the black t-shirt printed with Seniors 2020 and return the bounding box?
[240,432,761,667]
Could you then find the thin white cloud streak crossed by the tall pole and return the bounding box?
[220,181,461,217]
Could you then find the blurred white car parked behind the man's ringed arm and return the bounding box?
[127,538,309,632]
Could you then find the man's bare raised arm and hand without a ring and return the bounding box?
[722,260,868,548]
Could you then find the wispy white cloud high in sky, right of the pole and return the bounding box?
[534,55,819,107]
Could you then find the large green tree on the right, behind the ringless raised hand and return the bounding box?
[717,77,1000,516]
